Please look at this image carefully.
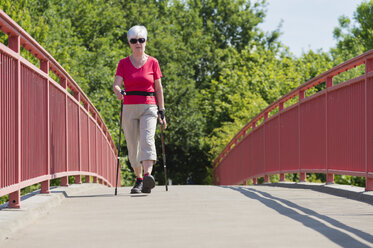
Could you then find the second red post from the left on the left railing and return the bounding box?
[40,60,51,194]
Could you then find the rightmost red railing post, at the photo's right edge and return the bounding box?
[365,58,373,191]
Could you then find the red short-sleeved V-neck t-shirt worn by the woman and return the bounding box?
[115,56,162,104]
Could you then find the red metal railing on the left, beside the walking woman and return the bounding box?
[0,10,120,207]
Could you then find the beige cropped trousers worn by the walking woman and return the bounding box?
[122,104,158,168]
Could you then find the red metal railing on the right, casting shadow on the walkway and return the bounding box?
[214,50,373,190]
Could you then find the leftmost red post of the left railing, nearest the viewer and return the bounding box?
[8,35,22,208]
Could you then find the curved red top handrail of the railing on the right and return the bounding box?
[214,50,373,191]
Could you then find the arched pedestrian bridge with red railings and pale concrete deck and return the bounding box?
[0,10,373,247]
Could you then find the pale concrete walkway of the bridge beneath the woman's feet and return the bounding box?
[0,184,373,248]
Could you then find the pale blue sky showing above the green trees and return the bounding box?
[259,0,365,57]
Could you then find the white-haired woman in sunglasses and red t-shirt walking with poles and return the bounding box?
[113,26,167,194]
